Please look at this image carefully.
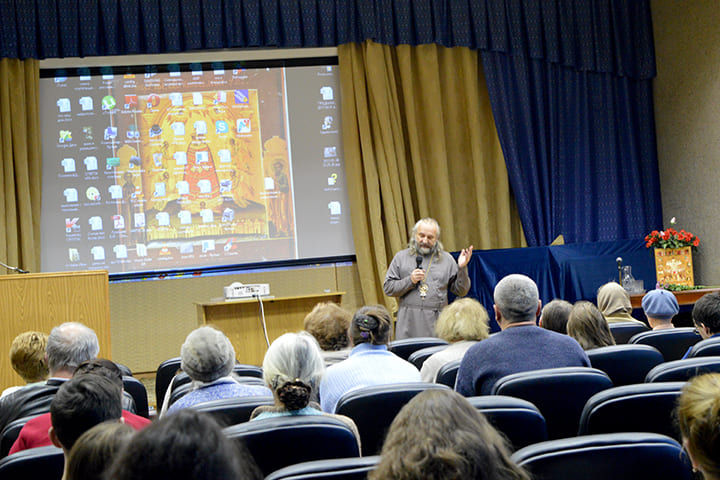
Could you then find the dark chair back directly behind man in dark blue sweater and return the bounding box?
[492,367,613,439]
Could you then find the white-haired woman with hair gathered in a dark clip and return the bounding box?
[250,332,360,443]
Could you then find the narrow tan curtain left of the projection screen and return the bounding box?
[0,58,42,274]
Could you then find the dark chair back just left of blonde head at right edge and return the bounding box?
[578,382,685,437]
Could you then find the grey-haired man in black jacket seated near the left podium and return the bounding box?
[0,322,100,432]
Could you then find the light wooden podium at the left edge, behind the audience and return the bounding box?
[0,270,111,389]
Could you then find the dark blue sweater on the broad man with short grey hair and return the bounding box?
[455,325,590,397]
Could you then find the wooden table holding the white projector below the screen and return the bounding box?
[196,292,345,365]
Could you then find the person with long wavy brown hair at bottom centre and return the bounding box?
[368,390,530,480]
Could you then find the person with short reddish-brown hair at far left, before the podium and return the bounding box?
[0,332,50,398]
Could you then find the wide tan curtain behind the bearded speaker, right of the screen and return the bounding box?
[338,41,524,309]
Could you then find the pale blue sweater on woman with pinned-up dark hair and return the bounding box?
[320,343,420,413]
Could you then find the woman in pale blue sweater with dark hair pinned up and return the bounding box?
[320,305,420,413]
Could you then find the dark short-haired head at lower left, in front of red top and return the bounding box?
[48,374,122,459]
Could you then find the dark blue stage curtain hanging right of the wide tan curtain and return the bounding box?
[481,1,662,246]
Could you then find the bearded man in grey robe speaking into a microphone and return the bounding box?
[383,218,473,339]
